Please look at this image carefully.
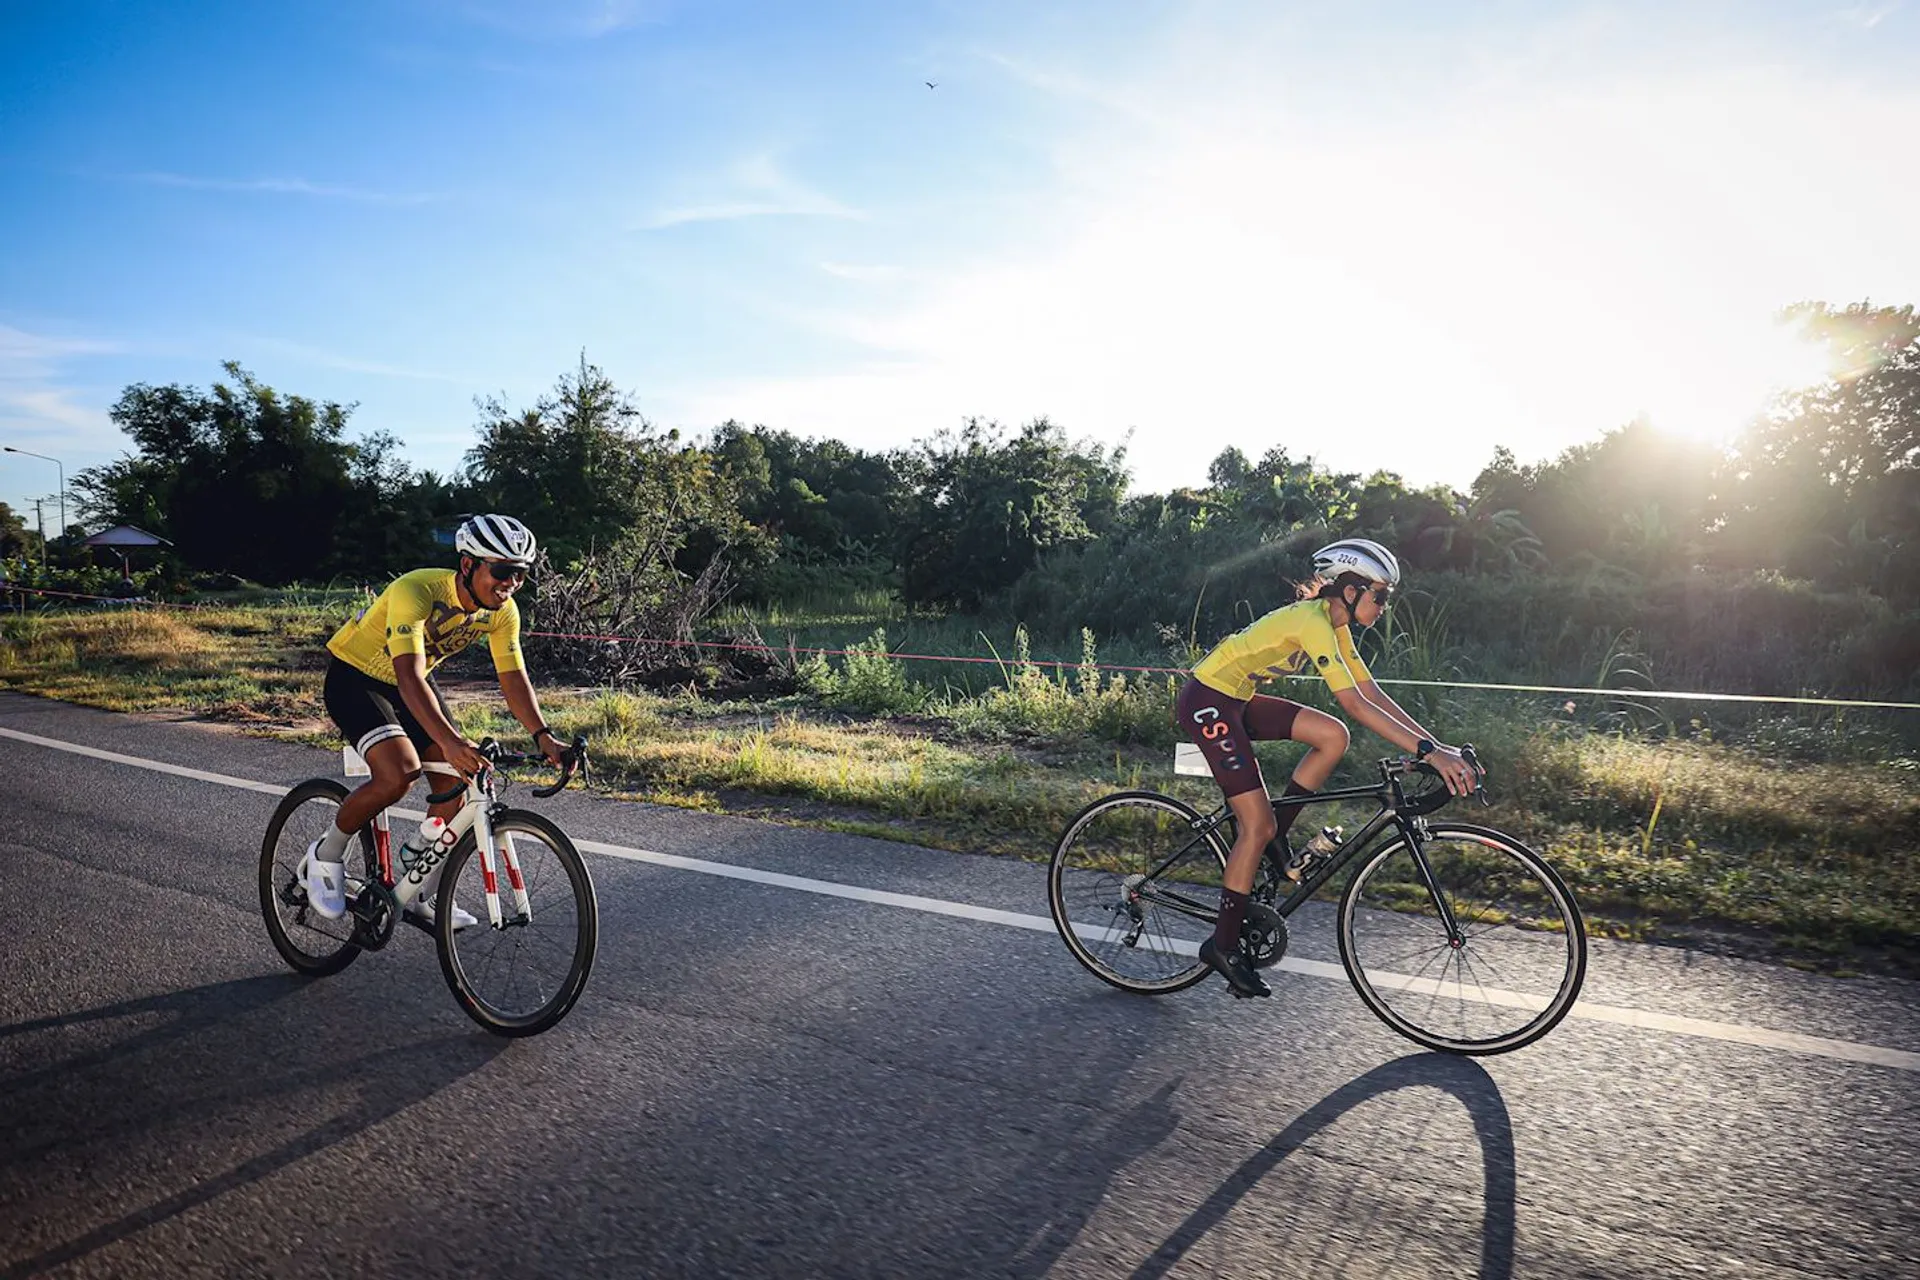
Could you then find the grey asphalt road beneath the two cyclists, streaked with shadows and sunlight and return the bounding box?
[0,695,1920,1280]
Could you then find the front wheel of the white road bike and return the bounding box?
[434,810,599,1036]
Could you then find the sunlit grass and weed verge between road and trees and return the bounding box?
[0,603,1920,973]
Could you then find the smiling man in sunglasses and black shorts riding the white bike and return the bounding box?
[301,516,563,929]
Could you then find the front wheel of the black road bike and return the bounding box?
[1340,823,1586,1054]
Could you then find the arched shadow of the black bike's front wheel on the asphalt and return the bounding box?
[1133,1054,1517,1280]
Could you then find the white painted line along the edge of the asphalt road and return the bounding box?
[11,727,1920,1071]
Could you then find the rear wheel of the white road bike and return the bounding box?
[259,777,374,977]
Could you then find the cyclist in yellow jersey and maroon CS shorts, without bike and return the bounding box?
[1175,537,1478,996]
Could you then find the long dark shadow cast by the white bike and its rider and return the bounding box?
[0,975,507,1280]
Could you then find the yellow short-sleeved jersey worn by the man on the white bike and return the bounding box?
[326,568,526,685]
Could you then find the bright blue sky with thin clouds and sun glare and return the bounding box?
[0,0,1920,529]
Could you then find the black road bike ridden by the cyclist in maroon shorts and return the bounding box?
[1046,748,1586,1054]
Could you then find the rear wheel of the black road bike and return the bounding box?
[1046,791,1227,996]
